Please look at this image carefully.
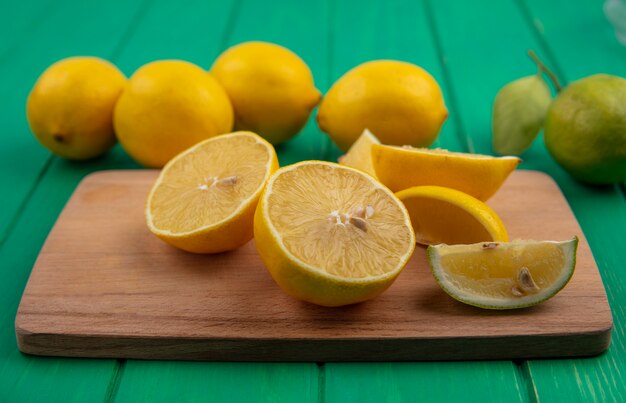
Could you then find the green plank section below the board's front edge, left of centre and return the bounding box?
[115,361,318,403]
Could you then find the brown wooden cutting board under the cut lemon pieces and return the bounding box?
[15,171,612,361]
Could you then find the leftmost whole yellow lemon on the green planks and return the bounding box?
[26,57,126,160]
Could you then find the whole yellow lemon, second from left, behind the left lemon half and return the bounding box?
[114,60,233,168]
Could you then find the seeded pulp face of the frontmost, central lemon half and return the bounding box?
[268,165,413,279]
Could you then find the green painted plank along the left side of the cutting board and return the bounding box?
[0,148,136,402]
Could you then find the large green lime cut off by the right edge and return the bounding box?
[544,74,626,184]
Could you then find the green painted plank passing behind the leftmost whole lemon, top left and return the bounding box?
[0,0,146,243]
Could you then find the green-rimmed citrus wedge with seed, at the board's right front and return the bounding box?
[426,237,578,309]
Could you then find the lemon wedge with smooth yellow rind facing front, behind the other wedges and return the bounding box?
[372,144,522,201]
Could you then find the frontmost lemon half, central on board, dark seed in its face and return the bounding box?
[254,161,415,306]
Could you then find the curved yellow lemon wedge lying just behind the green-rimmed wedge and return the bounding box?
[396,186,509,245]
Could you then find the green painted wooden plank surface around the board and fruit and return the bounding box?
[0,0,626,403]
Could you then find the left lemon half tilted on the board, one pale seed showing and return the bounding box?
[145,132,278,253]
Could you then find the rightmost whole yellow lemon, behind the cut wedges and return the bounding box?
[317,60,448,151]
